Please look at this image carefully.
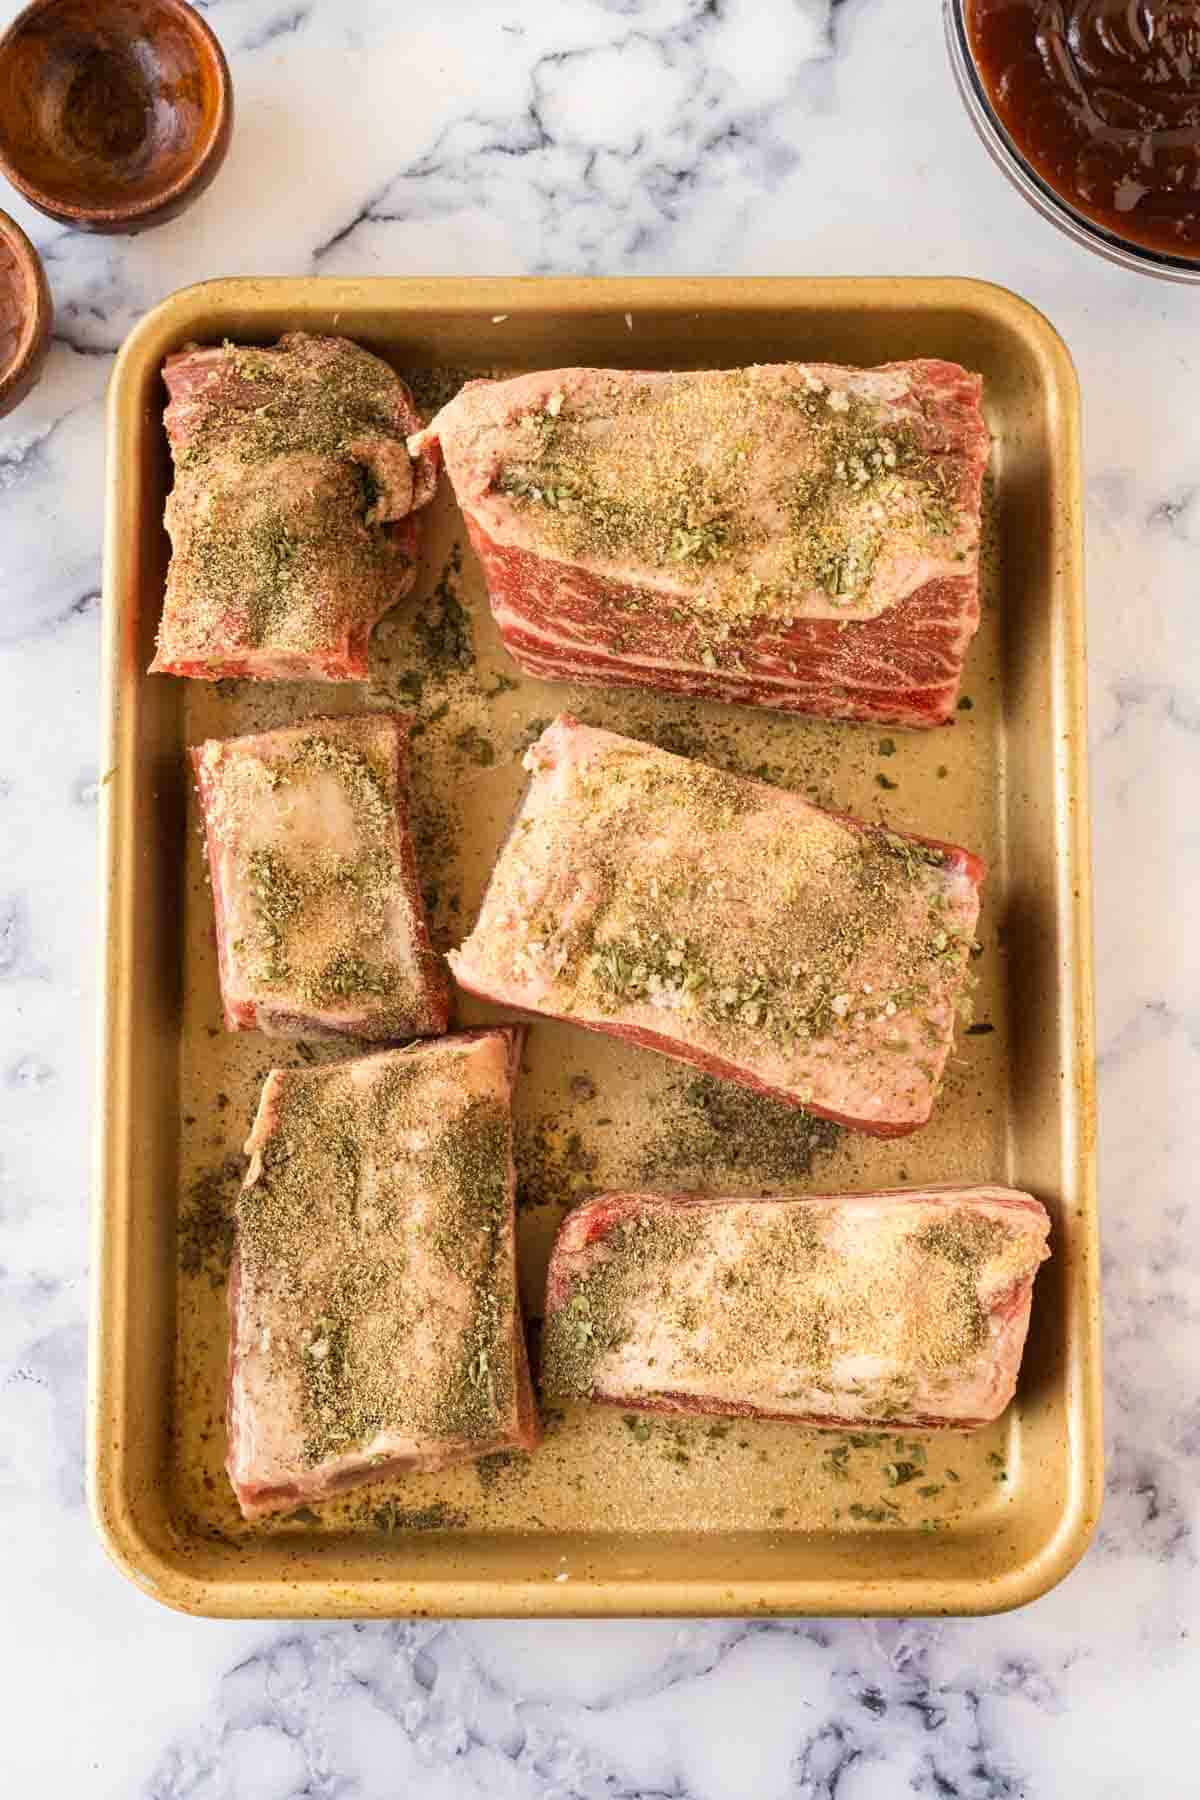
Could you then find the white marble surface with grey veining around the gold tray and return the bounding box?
[0,0,1200,1800]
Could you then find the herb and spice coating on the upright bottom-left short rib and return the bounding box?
[237,1046,515,1467]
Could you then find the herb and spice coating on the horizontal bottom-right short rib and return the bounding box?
[543,1195,1029,1432]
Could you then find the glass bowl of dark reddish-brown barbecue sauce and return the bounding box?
[945,0,1200,281]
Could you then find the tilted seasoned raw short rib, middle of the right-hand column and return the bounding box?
[450,718,982,1136]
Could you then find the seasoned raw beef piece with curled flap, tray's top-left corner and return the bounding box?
[151,331,437,680]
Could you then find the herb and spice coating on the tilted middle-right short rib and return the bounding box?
[482,738,968,1102]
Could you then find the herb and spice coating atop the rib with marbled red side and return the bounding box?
[493,369,963,626]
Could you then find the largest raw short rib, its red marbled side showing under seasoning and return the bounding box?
[410,360,988,725]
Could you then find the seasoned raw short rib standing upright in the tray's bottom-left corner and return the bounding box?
[228,1028,538,1517]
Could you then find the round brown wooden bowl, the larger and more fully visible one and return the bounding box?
[0,0,234,232]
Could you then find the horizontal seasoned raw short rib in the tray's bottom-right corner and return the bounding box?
[542,1186,1049,1425]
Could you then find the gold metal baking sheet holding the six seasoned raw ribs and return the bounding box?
[94,281,1099,1615]
